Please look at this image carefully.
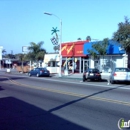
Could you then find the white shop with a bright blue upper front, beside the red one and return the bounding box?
[83,40,128,72]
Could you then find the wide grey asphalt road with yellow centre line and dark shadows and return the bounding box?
[0,74,130,130]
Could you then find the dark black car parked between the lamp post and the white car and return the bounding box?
[83,68,101,81]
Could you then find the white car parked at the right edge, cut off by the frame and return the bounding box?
[110,67,130,84]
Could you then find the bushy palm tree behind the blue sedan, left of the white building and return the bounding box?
[27,42,46,62]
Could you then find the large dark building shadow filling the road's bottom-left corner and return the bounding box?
[0,97,91,130]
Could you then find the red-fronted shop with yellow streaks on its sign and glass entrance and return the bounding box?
[61,41,89,73]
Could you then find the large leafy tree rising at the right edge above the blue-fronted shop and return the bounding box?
[113,17,130,53]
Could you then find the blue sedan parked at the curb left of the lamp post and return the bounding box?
[28,68,50,77]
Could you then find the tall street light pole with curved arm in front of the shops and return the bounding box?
[44,12,62,77]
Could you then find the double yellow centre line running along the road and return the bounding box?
[6,79,130,106]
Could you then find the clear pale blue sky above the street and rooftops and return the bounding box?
[0,0,130,54]
